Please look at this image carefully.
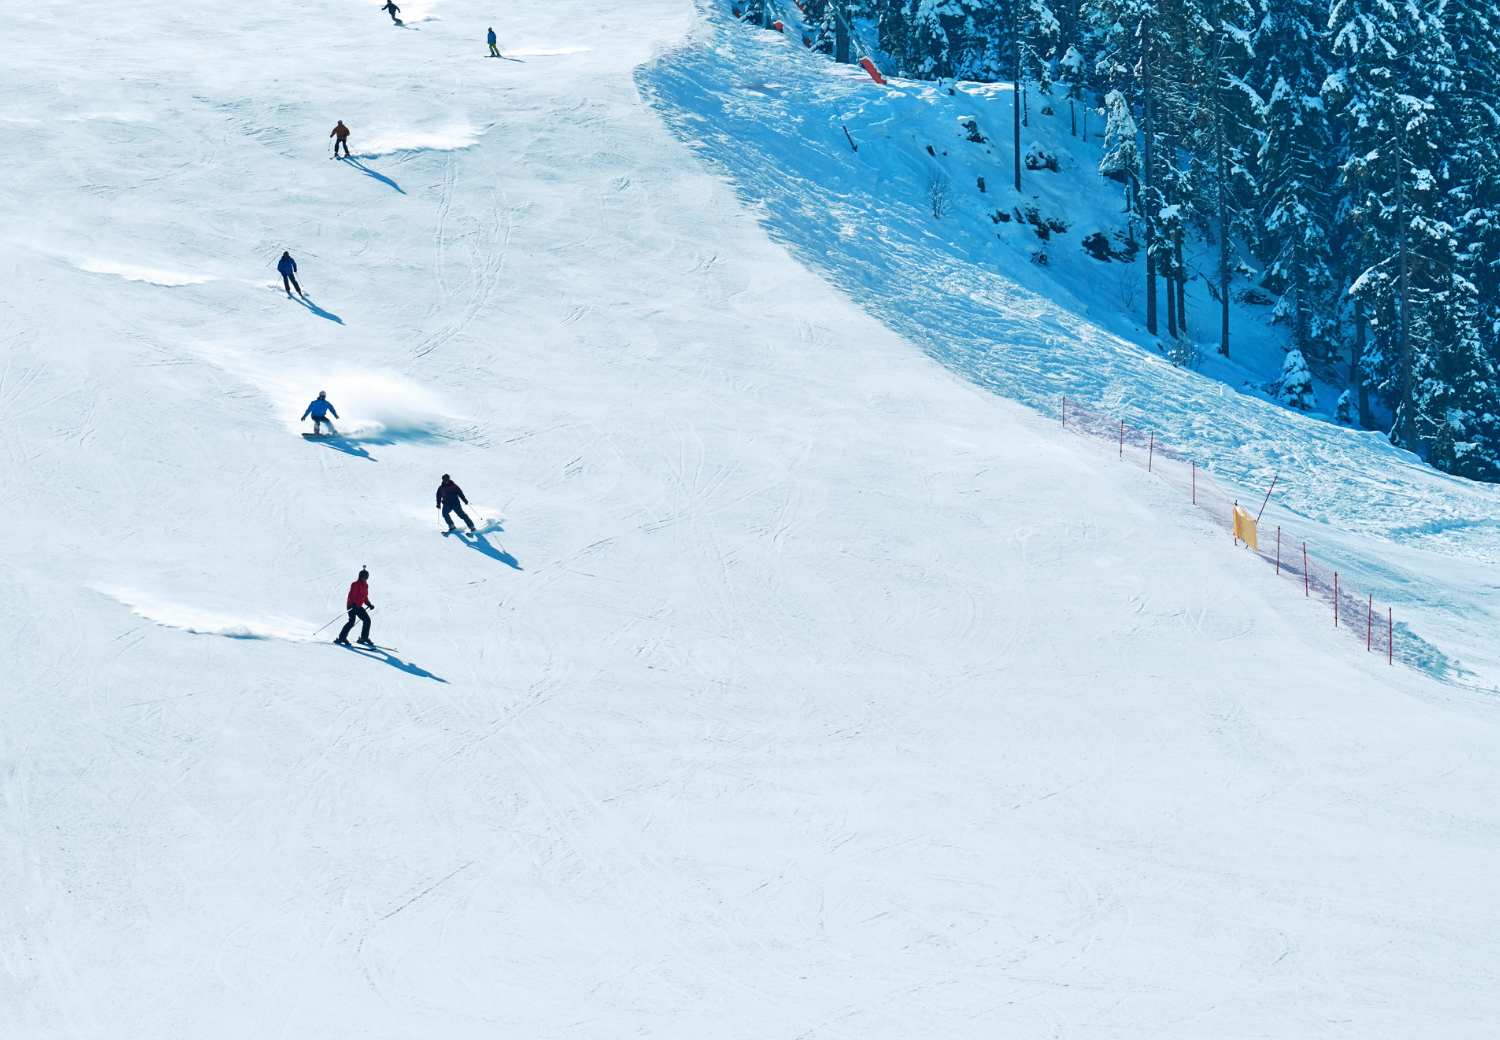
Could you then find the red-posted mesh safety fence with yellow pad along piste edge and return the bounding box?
[1059,396,1452,674]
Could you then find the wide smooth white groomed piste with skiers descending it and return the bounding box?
[0,0,1500,1040]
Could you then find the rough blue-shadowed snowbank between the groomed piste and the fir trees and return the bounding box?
[641,12,1500,692]
